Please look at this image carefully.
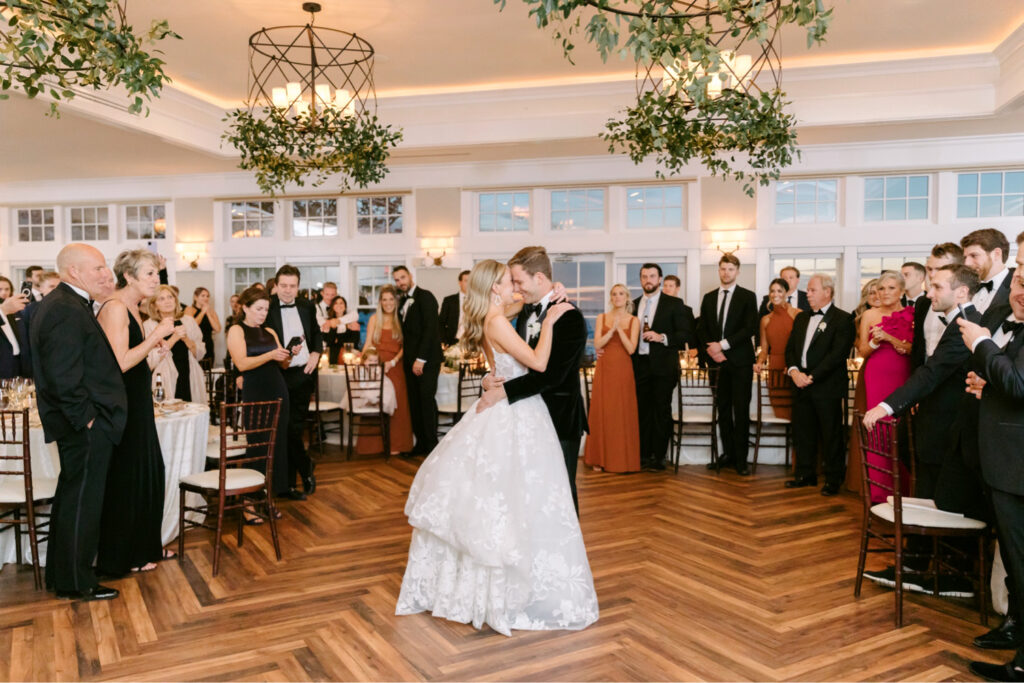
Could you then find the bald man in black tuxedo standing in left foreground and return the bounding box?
[29,244,128,600]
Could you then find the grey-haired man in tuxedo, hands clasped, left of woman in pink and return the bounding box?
[785,273,857,496]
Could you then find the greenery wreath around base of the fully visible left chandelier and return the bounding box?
[221,106,401,195]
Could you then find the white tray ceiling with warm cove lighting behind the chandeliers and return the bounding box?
[6,0,1024,182]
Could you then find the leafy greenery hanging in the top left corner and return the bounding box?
[0,0,180,116]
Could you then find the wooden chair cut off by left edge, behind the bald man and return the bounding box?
[0,409,57,591]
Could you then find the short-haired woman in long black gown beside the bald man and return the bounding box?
[96,249,174,577]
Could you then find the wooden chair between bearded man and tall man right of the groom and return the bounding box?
[671,368,718,472]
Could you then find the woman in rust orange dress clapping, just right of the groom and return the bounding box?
[584,285,640,472]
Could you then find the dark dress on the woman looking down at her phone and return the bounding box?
[242,323,289,496]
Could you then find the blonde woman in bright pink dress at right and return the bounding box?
[857,270,913,503]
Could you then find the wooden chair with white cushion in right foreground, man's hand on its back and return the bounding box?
[853,412,988,629]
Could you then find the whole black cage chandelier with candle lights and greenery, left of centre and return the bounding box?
[222,2,401,195]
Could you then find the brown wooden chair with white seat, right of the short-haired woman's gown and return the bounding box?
[178,398,281,577]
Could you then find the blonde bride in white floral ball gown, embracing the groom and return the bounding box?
[395,260,597,636]
